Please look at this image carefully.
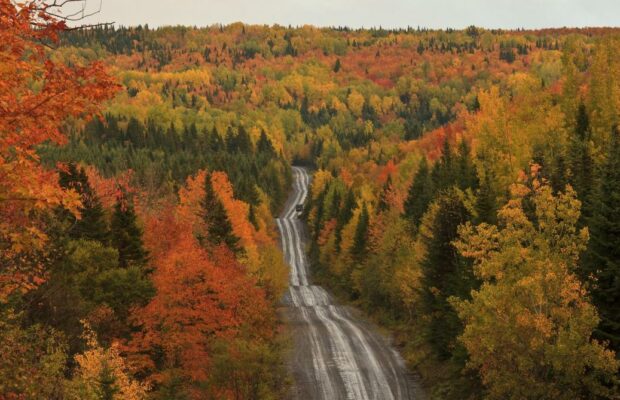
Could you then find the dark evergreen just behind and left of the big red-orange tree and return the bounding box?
[111,193,148,268]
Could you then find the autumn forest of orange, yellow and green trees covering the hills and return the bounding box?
[0,0,620,400]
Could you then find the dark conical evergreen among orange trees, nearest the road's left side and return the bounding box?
[199,173,241,254]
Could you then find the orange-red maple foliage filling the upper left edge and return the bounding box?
[0,0,118,300]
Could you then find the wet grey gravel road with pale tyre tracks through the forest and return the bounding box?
[276,167,422,400]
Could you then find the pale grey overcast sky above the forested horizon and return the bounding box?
[76,0,620,28]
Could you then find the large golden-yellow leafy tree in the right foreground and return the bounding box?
[453,172,618,400]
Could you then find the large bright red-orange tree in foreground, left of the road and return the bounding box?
[127,205,275,399]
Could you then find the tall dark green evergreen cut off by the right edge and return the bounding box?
[582,127,620,351]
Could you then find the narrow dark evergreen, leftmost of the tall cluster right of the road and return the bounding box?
[403,158,435,231]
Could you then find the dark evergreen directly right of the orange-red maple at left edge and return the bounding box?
[59,163,109,243]
